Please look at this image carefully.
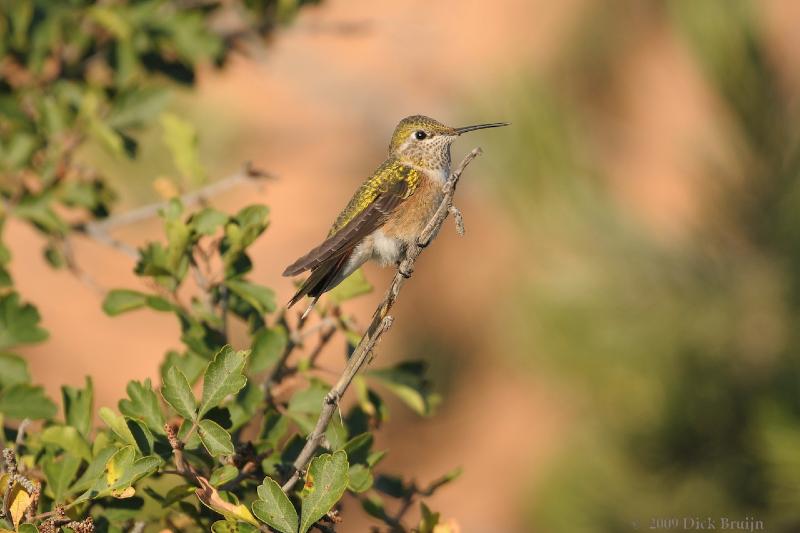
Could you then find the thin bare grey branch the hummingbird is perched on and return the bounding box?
[282,148,481,492]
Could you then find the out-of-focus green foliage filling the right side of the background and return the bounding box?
[482,0,800,533]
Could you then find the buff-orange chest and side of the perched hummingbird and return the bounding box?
[382,170,444,244]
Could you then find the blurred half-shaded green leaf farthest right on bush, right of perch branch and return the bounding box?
[367,361,441,416]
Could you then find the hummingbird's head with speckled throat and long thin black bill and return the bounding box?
[389,115,508,171]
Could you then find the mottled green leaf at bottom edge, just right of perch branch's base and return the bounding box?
[299,451,348,533]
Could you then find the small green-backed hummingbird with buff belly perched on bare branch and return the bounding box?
[283,115,508,318]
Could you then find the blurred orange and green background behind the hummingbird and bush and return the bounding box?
[5,0,800,533]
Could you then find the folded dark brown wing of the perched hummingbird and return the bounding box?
[283,179,408,276]
